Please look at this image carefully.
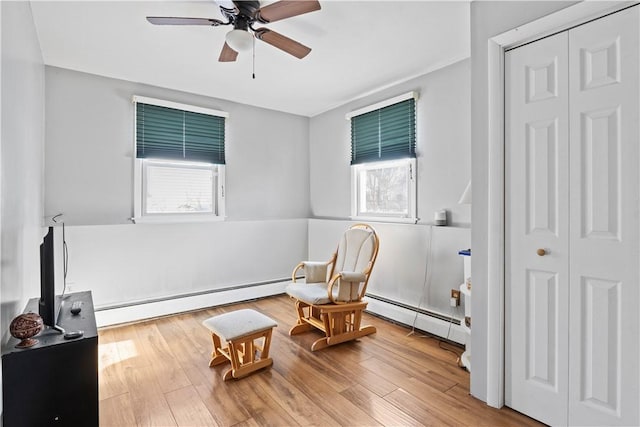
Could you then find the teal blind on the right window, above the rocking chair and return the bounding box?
[351,98,416,165]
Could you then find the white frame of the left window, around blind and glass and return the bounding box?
[131,95,229,224]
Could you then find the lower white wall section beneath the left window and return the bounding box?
[66,219,307,309]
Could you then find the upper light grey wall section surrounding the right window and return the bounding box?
[310,59,471,227]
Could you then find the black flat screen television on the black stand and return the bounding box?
[38,227,60,329]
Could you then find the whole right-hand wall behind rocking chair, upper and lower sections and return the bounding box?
[309,59,471,318]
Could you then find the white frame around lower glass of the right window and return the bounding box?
[351,158,418,223]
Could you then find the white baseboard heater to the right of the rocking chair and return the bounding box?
[367,298,467,344]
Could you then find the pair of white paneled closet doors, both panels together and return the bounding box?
[505,7,640,426]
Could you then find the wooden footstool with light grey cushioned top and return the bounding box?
[202,309,278,381]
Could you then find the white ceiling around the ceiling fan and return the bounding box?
[31,0,469,116]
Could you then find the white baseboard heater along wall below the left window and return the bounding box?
[96,282,287,328]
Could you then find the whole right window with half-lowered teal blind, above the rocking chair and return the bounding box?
[347,92,417,221]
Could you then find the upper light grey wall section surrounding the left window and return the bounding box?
[45,66,309,225]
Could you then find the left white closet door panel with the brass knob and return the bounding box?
[505,32,569,425]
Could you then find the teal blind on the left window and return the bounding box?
[136,102,225,164]
